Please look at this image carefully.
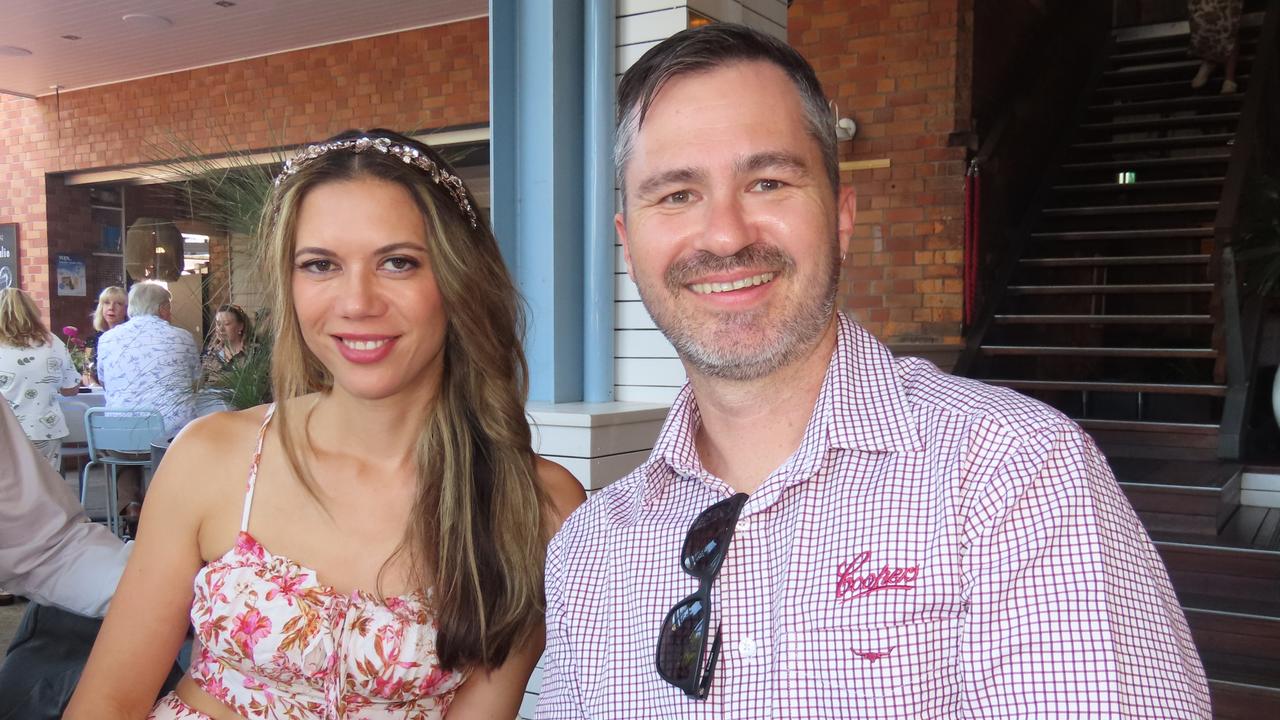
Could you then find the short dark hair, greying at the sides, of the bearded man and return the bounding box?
[613,23,840,199]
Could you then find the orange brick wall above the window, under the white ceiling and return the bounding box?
[0,18,489,319]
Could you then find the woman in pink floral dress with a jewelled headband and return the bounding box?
[65,131,584,720]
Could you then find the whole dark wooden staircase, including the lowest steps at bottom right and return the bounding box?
[957,8,1280,720]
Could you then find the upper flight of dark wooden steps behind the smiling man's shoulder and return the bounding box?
[969,20,1258,460]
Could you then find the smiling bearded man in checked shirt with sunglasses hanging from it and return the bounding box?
[538,24,1210,719]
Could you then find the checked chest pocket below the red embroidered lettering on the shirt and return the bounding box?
[782,616,961,717]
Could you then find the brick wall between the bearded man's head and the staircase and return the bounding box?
[787,0,973,345]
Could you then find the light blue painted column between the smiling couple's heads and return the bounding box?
[489,0,613,402]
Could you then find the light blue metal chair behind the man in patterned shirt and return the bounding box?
[81,407,164,536]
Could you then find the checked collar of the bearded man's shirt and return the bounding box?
[643,313,922,503]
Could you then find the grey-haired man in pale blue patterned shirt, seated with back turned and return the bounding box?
[97,282,200,512]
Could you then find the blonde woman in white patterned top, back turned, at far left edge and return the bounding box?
[0,287,79,473]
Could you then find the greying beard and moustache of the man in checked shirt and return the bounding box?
[636,242,840,380]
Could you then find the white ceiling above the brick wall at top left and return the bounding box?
[0,0,489,96]
